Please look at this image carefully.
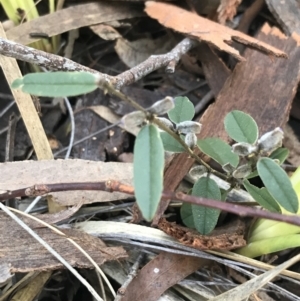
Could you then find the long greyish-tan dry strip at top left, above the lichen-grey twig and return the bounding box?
[6,1,144,45]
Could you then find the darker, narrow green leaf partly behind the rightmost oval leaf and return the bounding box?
[243,180,281,213]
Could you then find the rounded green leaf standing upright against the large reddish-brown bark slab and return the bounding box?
[224,110,258,144]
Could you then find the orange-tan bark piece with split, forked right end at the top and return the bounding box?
[145,1,287,61]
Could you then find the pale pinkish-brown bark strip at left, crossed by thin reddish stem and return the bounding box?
[0,159,133,206]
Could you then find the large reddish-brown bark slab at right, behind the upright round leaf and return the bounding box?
[153,25,300,225]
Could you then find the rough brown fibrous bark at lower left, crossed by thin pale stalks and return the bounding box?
[0,213,127,273]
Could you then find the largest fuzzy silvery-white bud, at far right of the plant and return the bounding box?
[258,128,283,154]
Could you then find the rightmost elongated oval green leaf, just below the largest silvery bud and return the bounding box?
[257,158,299,213]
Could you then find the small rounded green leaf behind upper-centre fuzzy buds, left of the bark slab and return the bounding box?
[168,96,195,123]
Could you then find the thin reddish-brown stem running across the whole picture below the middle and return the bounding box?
[0,181,300,226]
